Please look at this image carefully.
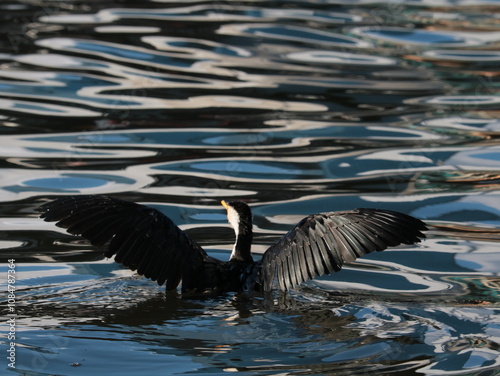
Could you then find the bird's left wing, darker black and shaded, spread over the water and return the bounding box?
[39,195,207,290]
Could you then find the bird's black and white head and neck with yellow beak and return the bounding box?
[221,200,253,262]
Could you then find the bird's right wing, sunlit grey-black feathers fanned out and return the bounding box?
[260,209,427,291]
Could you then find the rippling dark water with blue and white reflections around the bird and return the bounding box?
[0,0,500,376]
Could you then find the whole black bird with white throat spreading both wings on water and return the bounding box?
[40,195,427,293]
